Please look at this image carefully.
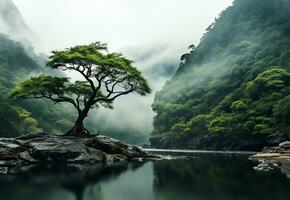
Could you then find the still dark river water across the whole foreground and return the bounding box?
[0,153,290,200]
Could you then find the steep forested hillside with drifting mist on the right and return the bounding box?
[151,0,290,150]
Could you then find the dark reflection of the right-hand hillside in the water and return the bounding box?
[154,154,290,200]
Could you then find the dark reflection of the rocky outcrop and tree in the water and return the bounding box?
[0,163,142,200]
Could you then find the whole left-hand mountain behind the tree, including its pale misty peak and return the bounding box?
[0,0,74,137]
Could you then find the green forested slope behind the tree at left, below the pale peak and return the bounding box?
[0,35,74,137]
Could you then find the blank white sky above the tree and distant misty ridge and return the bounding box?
[13,0,232,53]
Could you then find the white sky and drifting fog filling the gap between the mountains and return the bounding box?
[9,0,232,143]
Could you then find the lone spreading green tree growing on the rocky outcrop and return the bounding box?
[9,42,151,136]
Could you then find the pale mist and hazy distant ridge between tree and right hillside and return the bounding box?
[86,44,184,143]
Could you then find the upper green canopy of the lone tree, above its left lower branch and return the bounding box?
[47,42,151,95]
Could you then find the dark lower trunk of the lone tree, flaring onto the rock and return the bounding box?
[65,112,90,137]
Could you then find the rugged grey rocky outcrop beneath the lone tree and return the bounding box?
[0,133,157,171]
